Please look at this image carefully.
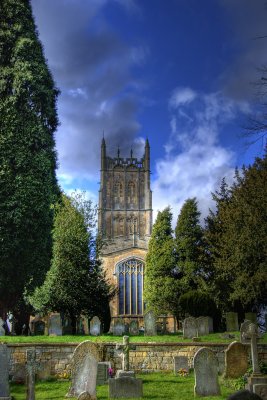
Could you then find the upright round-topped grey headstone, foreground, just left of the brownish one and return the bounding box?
[193,347,220,396]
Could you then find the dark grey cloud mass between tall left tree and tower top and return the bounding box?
[32,0,147,179]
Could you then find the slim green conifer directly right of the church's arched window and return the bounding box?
[144,207,182,315]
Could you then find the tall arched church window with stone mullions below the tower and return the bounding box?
[117,258,144,315]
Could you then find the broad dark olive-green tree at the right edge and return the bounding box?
[206,153,267,311]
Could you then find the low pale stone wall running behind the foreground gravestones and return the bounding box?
[8,343,267,381]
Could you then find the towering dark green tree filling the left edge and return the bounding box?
[0,0,58,322]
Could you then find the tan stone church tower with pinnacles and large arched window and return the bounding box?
[98,139,152,322]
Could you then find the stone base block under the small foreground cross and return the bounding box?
[108,376,143,399]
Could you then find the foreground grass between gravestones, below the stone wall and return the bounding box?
[11,372,235,400]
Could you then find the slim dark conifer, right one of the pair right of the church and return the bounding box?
[175,198,205,290]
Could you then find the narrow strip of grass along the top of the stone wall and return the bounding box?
[1,332,267,343]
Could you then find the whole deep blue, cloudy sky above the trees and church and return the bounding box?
[32,0,267,221]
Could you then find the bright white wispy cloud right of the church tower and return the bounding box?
[152,88,249,225]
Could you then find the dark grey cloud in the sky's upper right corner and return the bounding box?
[219,0,267,101]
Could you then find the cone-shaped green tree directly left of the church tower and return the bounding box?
[29,194,112,333]
